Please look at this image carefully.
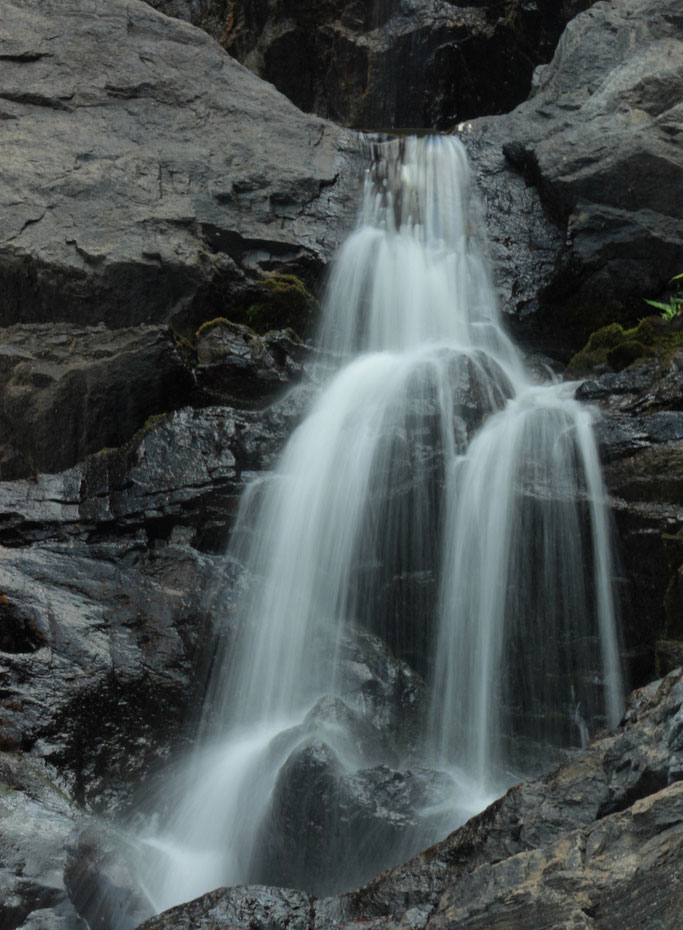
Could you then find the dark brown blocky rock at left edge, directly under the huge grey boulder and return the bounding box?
[0,323,193,480]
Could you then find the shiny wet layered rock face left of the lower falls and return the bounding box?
[0,374,312,930]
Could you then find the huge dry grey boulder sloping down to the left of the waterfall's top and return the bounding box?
[0,0,358,329]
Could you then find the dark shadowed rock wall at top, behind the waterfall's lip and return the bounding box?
[205,0,590,129]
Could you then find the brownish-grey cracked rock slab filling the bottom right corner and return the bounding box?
[425,784,683,930]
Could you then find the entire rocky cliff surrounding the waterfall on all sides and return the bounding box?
[0,0,683,930]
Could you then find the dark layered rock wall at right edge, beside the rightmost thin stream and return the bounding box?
[576,344,683,685]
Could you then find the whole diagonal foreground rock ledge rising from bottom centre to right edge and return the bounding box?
[136,670,683,930]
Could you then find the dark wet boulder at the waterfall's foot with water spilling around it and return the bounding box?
[256,739,453,894]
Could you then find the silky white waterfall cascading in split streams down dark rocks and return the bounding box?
[132,137,622,909]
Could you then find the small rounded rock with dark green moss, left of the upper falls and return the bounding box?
[246,274,315,336]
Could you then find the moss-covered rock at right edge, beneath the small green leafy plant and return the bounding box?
[566,317,683,378]
